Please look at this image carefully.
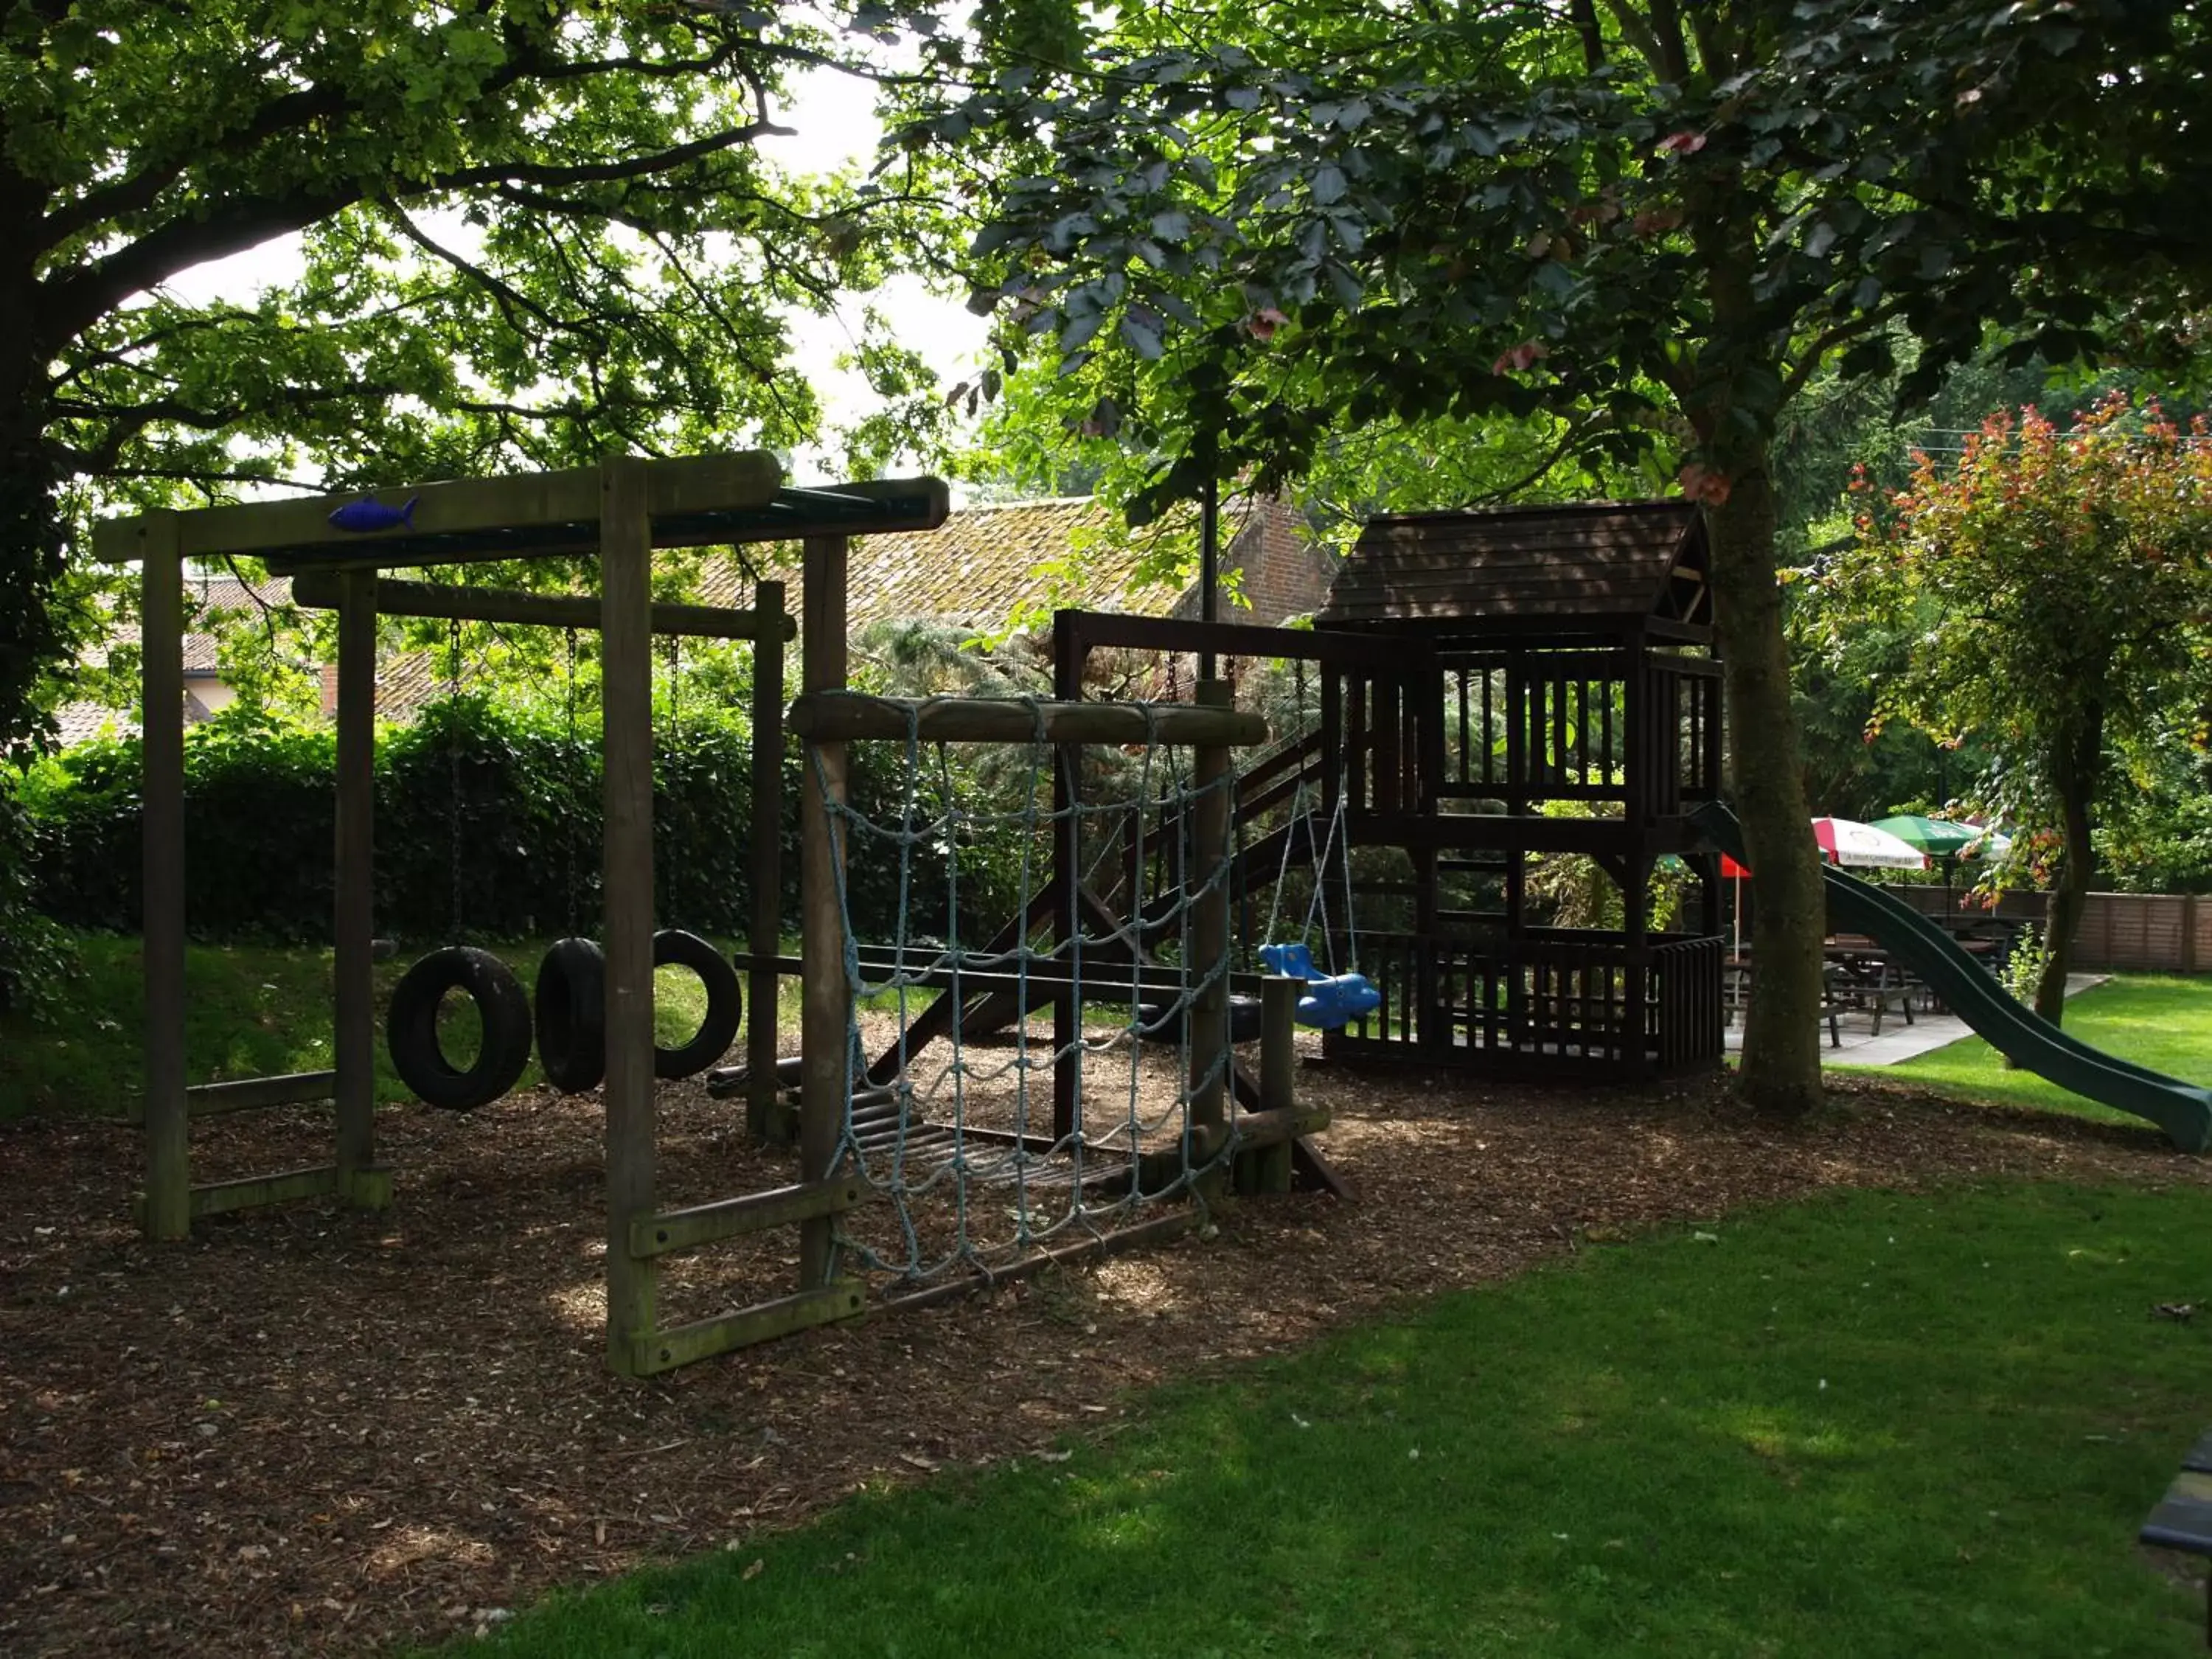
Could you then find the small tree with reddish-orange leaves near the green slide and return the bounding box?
[1829,394,2212,1020]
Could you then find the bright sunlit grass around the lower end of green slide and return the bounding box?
[1836,973,2212,1124]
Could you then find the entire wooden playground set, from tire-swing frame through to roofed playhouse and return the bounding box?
[95,453,1721,1376]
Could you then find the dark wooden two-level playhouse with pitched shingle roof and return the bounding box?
[1316,502,1723,1079]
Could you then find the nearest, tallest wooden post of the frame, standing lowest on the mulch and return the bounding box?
[599,456,655,1376]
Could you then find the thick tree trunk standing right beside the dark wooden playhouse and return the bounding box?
[1705,462,1827,1115]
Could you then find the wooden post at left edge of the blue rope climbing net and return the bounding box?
[799,535,852,1292]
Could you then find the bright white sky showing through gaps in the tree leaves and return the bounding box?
[166,71,987,484]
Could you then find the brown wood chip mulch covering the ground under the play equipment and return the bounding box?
[0,1071,2212,1659]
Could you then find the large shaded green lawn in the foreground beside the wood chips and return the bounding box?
[440,1186,2212,1659]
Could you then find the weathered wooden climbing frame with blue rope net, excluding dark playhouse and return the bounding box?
[95,453,1325,1376]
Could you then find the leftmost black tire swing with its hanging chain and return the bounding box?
[385,619,531,1113]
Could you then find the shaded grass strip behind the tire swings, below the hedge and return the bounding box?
[0,933,799,1119]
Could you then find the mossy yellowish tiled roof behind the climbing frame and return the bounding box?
[699,495,1183,630]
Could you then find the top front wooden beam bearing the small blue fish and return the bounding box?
[93,449,783,564]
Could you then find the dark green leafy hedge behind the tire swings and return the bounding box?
[15,697,1020,942]
